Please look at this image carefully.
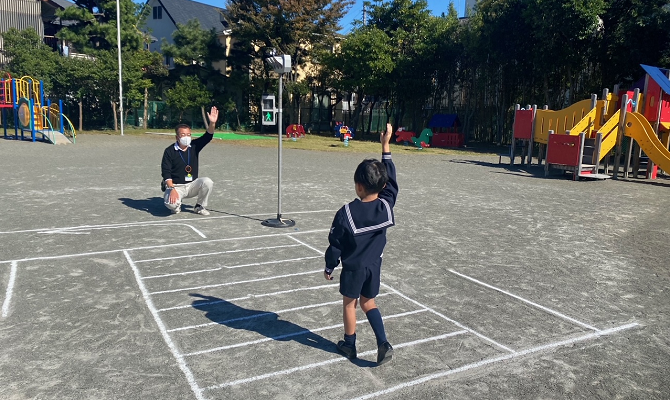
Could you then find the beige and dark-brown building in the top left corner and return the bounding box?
[0,0,74,65]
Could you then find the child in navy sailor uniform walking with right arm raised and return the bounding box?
[323,124,398,364]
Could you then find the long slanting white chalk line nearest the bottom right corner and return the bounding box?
[350,323,639,400]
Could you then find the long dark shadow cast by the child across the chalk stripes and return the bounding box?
[189,293,376,367]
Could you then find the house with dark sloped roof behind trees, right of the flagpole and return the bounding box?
[144,0,231,72]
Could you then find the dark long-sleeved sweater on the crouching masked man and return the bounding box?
[161,132,214,184]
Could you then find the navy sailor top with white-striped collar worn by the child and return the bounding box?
[325,153,398,274]
